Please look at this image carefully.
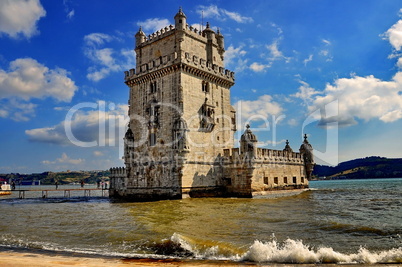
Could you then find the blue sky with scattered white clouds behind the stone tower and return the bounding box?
[0,0,402,173]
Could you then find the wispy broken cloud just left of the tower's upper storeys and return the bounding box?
[84,33,135,82]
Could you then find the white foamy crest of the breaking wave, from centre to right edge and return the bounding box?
[171,233,402,264]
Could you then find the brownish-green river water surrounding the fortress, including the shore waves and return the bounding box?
[0,179,402,264]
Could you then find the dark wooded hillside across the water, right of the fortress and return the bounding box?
[313,157,402,179]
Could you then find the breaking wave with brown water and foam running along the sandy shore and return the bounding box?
[0,233,402,264]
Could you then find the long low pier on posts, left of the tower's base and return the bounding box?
[3,188,109,199]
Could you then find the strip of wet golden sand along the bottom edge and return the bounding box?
[0,250,402,267]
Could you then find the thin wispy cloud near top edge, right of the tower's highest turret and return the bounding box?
[197,5,254,23]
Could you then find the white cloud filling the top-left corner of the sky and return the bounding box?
[0,0,46,39]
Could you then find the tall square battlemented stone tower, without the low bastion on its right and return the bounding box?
[110,9,236,200]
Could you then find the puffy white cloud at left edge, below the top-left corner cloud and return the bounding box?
[0,58,78,102]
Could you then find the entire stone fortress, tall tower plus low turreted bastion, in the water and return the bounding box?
[109,9,314,201]
